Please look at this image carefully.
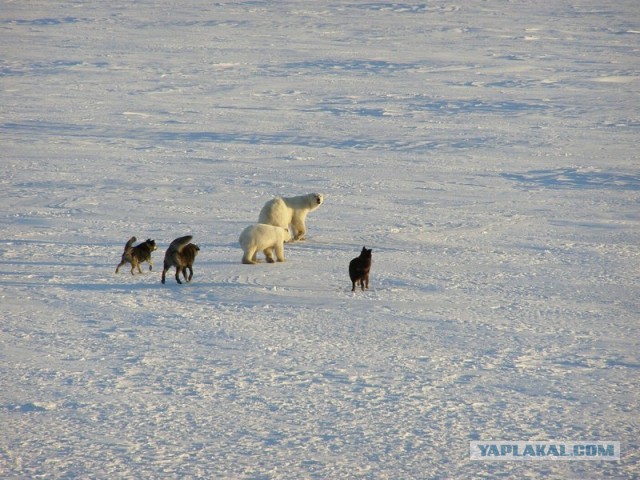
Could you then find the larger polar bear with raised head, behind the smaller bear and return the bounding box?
[258,193,324,240]
